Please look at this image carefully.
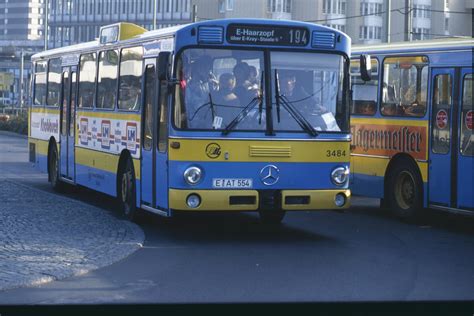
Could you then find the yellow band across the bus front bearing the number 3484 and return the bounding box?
[169,138,350,162]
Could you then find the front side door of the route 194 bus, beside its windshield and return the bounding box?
[141,59,168,215]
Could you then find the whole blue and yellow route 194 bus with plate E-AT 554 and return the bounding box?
[29,19,351,222]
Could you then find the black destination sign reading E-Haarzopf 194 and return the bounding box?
[226,24,309,46]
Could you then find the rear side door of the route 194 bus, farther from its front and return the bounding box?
[59,67,77,181]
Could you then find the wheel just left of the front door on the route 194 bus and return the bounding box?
[118,158,137,221]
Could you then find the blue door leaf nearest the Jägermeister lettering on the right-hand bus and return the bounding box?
[428,68,460,207]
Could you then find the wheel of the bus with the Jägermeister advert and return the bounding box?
[388,163,423,219]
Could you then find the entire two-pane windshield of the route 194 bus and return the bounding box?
[174,48,346,135]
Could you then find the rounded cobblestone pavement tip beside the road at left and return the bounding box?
[0,180,144,291]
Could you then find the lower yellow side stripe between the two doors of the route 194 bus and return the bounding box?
[75,147,140,180]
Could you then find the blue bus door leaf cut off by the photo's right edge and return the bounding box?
[456,68,474,210]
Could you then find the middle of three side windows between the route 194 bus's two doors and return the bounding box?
[96,50,118,109]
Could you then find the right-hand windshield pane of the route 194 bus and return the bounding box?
[271,52,345,132]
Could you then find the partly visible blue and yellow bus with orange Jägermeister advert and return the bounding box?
[351,38,474,217]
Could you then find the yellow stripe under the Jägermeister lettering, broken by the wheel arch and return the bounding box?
[351,156,428,182]
